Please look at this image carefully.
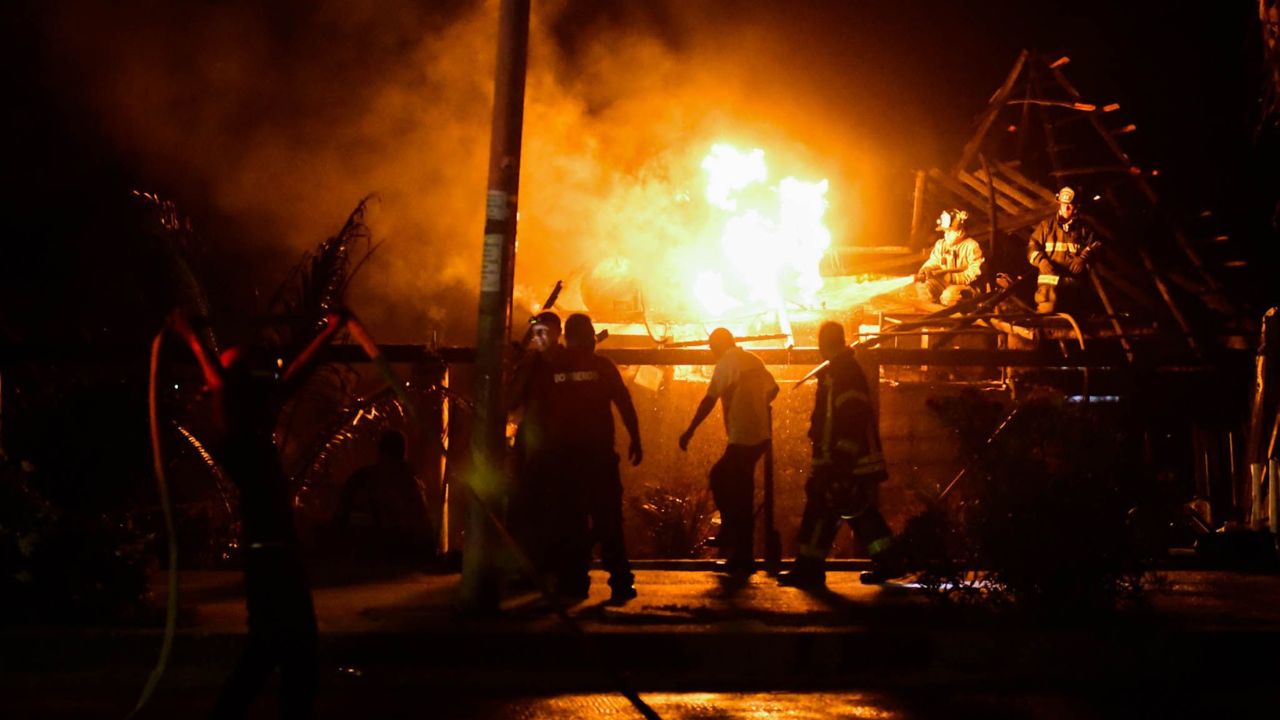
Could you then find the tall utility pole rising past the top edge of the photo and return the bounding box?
[462,0,530,612]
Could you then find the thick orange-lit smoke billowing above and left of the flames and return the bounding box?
[42,0,952,343]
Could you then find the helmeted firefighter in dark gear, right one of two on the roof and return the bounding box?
[1027,187,1101,314]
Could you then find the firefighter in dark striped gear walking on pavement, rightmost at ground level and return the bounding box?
[778,323,901,588]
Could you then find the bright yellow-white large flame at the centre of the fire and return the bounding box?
[689,143,831,316]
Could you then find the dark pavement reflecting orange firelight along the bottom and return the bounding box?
[0,564,1280,719]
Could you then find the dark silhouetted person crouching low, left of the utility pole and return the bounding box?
[334,430,435,562]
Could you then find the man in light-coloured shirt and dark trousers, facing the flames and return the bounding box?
[680,328,778,579]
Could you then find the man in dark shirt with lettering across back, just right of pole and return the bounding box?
[535,314,644,602]
